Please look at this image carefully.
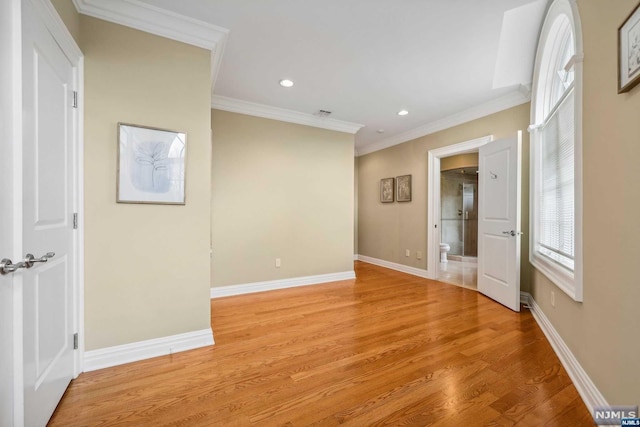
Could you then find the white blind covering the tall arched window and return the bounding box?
[536,88,575,271]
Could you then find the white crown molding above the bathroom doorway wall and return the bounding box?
[357,89,531,156]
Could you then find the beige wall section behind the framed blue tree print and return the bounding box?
[80,16,211,350]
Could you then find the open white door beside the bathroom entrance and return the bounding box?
[478,132,522,311]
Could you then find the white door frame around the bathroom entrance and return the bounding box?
[427,135,493,280]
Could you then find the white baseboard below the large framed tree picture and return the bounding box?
[84,328,214,372]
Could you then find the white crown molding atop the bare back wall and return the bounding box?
[211,95,364,134]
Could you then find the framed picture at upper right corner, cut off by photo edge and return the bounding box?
[618,4,640,93]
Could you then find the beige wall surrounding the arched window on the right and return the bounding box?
[531,0,640,405]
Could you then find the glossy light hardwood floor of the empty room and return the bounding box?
[50,262,593,427]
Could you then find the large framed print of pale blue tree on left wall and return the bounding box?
[116,123,187,205]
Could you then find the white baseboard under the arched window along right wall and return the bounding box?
[521,292,609,414]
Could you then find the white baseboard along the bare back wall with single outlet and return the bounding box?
[211,271,356,298]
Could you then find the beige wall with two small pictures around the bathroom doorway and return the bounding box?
[358,104,529,291]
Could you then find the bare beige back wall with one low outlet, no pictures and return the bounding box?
[212,110,354,287]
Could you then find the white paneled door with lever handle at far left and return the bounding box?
[22,1,75,426]
